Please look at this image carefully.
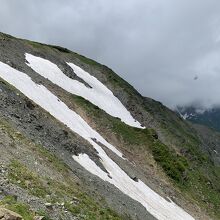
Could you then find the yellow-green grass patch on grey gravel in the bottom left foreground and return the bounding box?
[6,161,122,220]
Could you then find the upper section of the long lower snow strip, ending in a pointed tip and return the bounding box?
[0,62,123,158]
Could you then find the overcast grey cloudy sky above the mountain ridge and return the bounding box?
[0,0,220,107]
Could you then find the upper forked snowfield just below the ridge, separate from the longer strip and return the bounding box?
[25,53,143,128]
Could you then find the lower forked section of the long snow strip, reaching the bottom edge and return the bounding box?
[73,151,194,220]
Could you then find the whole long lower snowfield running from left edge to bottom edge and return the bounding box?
[0,62,194,220]
